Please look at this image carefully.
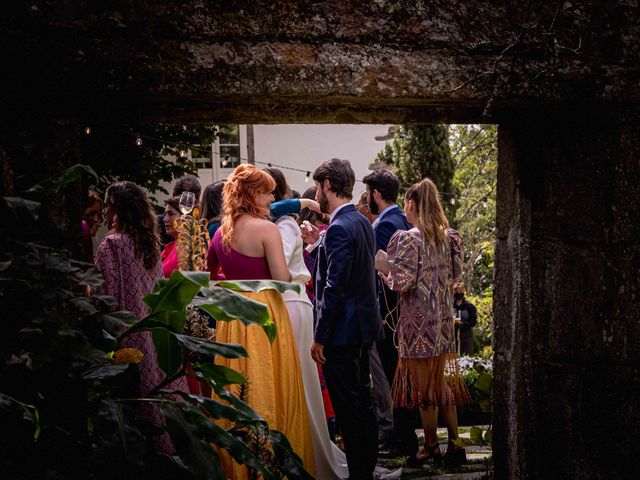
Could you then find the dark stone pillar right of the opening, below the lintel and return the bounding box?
[494,109,640,479]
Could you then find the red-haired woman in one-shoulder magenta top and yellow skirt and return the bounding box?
[207,164,315,479]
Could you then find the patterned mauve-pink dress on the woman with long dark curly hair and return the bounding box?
[95,233,189,453]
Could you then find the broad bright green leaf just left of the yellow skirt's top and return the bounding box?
[144,270,209,315]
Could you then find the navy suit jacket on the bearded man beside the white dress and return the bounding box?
[314,204,381,345]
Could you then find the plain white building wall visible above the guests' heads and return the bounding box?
[253,124,389,197]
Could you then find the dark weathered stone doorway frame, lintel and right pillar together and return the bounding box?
[0,0,640,479]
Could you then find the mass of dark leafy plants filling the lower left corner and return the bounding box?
[0,172,311,480]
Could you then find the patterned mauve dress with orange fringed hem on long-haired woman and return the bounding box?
[387,228,470,408]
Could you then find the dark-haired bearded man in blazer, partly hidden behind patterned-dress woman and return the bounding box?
[362,170,418,456]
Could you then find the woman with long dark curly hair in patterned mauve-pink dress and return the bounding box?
[95,182,188,453]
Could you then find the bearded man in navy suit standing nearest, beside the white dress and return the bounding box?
[304,159,381,480]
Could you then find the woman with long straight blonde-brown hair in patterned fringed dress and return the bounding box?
[379,178,469,467]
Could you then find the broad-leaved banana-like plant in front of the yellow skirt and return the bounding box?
[120,270,311,479]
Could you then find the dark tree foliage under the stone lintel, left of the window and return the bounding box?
[82,124,216,199]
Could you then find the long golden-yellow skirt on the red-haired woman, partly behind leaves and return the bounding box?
[215,290,315,480]
